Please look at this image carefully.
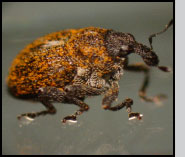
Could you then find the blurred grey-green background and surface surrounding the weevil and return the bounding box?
[2,2,173,155]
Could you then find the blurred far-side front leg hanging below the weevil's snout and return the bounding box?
[125,63,166,103]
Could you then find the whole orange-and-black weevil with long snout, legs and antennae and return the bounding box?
[7,20,173,123]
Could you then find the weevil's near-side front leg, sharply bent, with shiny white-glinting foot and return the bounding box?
[102,81,143,120]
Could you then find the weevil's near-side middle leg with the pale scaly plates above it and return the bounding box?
[62,67,106,123]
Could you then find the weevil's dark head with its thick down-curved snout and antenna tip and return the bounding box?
[105,31,169,72]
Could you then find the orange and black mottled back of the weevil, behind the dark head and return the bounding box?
[8,27,113,96]
